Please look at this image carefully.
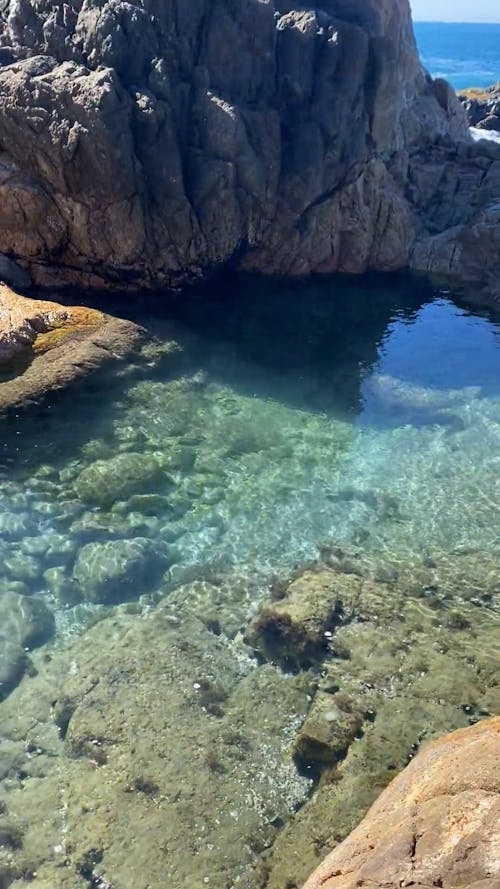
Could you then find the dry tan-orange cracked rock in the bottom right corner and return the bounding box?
[304,718,500,889]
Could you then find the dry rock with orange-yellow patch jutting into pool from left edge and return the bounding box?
[0,283,144,413]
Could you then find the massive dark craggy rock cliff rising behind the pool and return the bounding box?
[0,0,500,295]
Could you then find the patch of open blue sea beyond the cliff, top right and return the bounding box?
[415,22,500,90]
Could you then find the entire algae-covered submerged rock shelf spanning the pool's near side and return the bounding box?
[0,546,500,889]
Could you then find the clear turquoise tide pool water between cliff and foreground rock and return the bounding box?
[0,277,500,889]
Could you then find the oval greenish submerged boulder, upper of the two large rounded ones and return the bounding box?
[75,453,170,507]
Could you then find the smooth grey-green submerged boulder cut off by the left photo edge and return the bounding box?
[0,591,55,699]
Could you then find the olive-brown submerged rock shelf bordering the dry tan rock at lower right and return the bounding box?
[254,552,500,889]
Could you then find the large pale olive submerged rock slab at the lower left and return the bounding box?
[0,601,311,889]
